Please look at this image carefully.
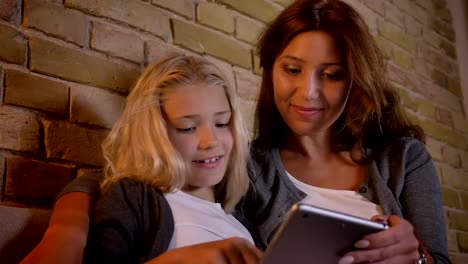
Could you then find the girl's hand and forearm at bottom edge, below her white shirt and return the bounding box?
[146,237,262,264]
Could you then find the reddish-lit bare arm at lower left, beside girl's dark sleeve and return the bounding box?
[20,192,92,264]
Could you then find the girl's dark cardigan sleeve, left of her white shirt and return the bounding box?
[84,179,173,263]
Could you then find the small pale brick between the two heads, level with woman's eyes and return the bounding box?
[234,68,261,101]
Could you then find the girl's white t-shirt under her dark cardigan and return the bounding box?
[164,190,254,249]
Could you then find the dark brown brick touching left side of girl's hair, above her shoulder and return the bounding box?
[42,120,106,166]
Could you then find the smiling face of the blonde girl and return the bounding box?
[162,83,234,197]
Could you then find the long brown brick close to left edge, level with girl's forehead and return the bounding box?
[4,70,68,115]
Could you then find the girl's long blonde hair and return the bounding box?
[102,54,249,213]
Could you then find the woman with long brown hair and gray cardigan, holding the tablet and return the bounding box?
[21,0,450,264]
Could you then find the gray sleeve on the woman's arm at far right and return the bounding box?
[400,140,451,263]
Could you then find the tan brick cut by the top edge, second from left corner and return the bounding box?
[23,0,88,47]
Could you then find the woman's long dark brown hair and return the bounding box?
[254,0,424,164]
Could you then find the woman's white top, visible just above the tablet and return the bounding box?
[286,172,382,219]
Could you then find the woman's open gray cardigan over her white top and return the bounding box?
[236,138,451,263]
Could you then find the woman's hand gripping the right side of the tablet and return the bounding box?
[338,215,424,264]
